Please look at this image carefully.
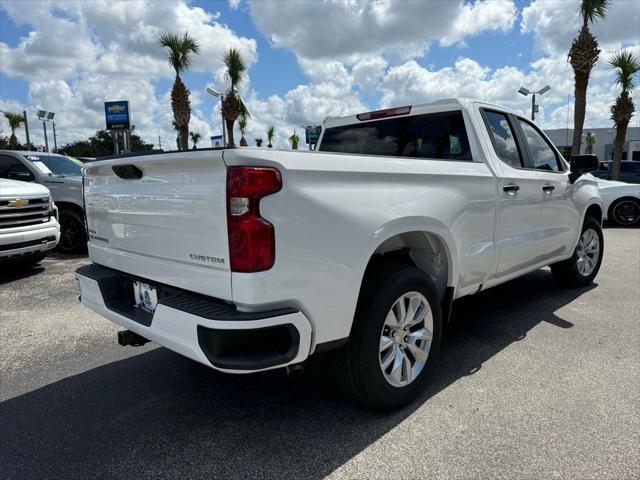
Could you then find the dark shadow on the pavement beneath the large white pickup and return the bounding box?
[0,270,587,479]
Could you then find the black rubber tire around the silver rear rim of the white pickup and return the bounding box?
[336,264,442,410]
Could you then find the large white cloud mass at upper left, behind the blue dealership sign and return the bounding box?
[0,0,257,145]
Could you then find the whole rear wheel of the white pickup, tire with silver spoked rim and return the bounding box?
[335,264,442,410]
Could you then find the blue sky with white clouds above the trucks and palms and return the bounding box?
[0,0,640,146]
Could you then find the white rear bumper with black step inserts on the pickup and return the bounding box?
[76,265,311,373]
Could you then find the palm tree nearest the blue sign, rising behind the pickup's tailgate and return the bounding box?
[159,32,200,150]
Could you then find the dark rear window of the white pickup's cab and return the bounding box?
[319,110,472,160]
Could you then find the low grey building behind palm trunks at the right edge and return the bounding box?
[544,127,640,161]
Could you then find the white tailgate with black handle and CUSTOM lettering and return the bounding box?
[84,150,231,300]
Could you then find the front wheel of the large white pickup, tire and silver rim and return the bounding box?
[551,217,604,288]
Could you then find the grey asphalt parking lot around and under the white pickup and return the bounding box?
[0,229,640,479]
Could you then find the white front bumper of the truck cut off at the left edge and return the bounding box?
[0,218,60,261]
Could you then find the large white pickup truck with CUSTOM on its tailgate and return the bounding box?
[76,99,603,408]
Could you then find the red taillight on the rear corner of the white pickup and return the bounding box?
[227,167,282,272]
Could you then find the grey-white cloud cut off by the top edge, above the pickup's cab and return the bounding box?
[249,0,515,63]
